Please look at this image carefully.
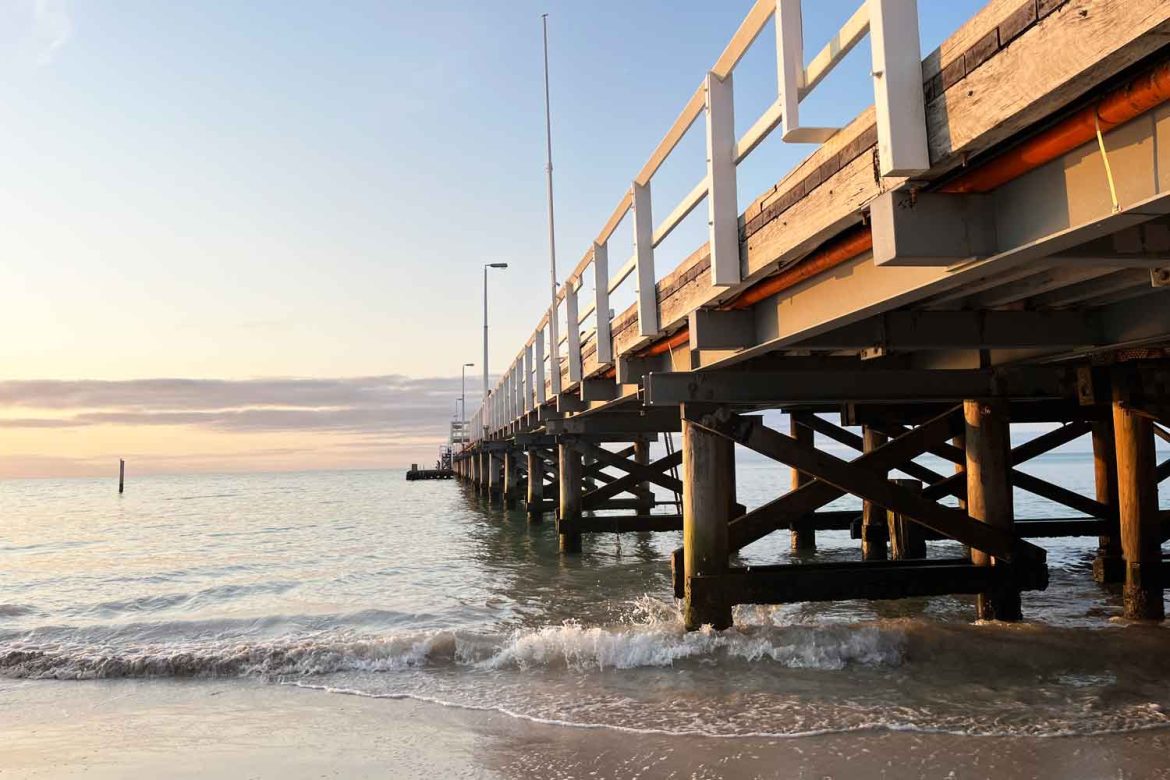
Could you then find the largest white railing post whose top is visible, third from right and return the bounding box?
[707,73,742,287]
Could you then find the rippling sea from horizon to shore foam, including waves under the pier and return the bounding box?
[0,455,1170,738]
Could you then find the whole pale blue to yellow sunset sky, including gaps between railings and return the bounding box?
[0,0,983,477]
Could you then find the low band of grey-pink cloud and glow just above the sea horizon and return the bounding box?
[0,374,491,478]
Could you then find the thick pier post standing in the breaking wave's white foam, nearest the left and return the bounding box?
[682,406,735,630]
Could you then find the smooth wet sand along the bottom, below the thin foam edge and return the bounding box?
[0,681,1170,780]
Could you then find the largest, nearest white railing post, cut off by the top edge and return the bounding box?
[870,0,930,177]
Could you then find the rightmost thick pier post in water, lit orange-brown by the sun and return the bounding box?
[1113,371,1165,620]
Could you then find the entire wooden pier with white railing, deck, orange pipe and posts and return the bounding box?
[453,0,1170,628]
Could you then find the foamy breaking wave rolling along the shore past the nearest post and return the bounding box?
[0,605,906,679]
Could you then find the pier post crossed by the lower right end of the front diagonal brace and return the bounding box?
[963,399,1023,621]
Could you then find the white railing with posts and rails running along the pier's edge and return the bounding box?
[469,0,930,441]
